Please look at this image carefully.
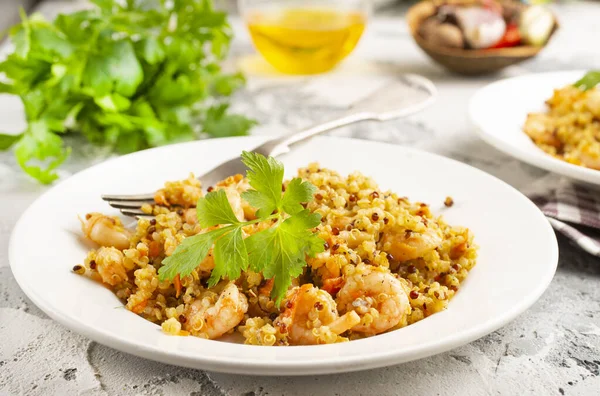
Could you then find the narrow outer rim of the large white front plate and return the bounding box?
[8,135,559,376]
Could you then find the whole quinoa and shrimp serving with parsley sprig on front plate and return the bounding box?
[73,152,477,345]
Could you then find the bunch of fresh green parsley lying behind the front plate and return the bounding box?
[0,0,254,183]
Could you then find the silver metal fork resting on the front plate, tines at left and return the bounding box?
[102,74,437,217]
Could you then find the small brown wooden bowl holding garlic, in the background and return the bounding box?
[406,0,558,75]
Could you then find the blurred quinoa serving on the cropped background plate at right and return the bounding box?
[523,71,600,170]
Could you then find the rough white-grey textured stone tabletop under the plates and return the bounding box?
[0,2,600,396]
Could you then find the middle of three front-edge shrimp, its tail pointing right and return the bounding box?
[273,284,360,345]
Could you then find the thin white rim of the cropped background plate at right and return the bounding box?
[468,70,600,186]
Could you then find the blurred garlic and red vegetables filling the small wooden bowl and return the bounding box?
[419,1,556,50]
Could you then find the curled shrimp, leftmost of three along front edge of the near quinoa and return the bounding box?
[185,282,248,340]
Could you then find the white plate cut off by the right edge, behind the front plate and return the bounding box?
[469,70,600,186]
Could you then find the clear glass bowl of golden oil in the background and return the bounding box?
[238,0,371,74]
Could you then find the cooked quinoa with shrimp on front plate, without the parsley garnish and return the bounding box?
[73,164,477,345]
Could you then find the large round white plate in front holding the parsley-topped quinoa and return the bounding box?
[9,137,558,375]
